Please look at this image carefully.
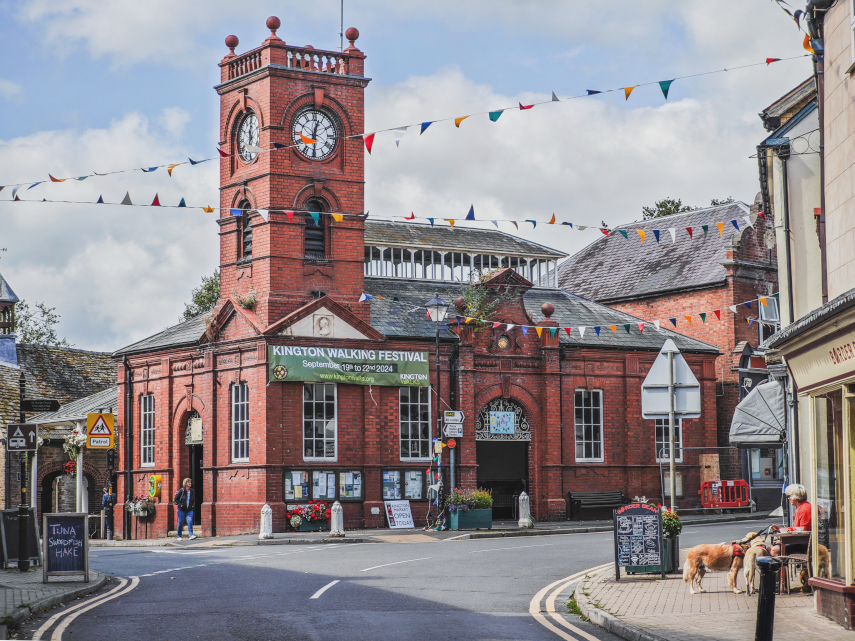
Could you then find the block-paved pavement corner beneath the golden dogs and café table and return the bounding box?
[574,549,855,641]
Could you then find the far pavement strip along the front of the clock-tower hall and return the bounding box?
[89,512,769,548]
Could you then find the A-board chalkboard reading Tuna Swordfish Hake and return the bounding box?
[43,512,89,583]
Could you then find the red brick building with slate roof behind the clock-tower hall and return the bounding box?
[558,202,781,507]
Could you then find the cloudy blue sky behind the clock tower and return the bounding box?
[0,0,811,350]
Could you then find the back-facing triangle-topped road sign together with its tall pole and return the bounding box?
[641,338,701,510]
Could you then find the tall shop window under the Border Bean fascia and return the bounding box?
[814,390,848,580]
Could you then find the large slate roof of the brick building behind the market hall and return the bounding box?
[558,202,749,303]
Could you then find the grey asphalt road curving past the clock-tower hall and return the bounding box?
[18,521,784,641]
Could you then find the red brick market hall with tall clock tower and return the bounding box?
[108,18,718,536]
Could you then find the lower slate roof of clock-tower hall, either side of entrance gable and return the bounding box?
[365,277,719,354]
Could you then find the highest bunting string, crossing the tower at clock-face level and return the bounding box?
[0,53,813,190]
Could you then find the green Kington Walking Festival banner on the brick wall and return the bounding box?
[267,345,430,387]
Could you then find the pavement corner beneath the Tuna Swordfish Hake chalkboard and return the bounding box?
[0,566,108,639]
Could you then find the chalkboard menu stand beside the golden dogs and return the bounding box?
[614,503,667,580]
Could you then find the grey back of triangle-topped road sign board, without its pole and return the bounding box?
[641,338,701,418]
